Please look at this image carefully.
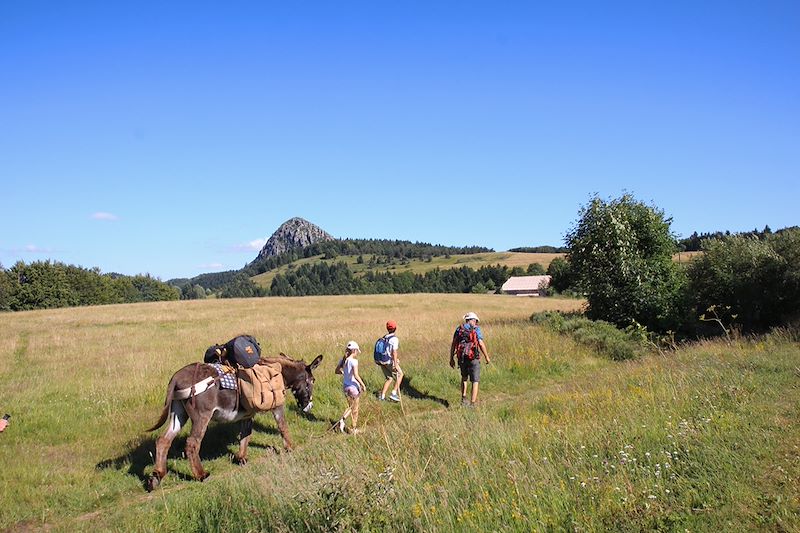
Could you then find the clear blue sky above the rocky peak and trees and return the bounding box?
[0,0,800,280]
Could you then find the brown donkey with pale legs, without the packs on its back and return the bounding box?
[147,354,322,490]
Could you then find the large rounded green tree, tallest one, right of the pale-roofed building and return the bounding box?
[566,194,683,332]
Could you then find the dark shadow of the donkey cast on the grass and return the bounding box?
[95,419,280,482]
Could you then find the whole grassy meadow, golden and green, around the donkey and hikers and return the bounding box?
[0,294,800,532]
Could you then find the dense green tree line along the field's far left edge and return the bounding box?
[0,261,181,311]
